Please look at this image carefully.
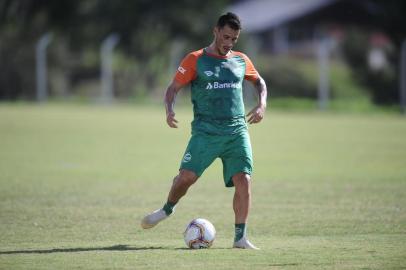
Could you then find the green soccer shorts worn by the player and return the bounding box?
[180,130,253,187]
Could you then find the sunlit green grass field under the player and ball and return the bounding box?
[0,104,406,270]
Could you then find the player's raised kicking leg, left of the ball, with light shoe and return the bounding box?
[141,169,198,229]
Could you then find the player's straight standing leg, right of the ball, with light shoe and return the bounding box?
[232,172,258,249]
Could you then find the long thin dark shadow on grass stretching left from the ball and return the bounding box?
[0,245,164,255]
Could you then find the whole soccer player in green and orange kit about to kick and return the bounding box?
[141,12,267,249]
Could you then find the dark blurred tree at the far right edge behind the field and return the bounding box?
[343,0,406,105]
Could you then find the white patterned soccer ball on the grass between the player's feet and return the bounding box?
[183,218,216,249]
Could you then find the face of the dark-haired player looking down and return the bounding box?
[214,25,240,56]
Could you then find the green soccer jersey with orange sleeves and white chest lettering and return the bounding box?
[174,49,259,135]
